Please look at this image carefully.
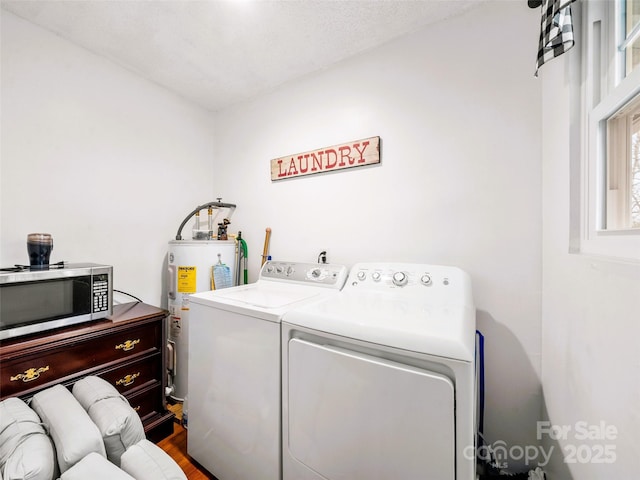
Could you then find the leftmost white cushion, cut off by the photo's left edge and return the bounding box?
[0,398,57,480]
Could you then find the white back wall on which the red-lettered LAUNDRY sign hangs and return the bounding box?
[214,2,541,465]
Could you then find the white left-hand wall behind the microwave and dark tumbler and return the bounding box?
[0,10,215,305]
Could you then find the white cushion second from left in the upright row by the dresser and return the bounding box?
[31,385,106,473]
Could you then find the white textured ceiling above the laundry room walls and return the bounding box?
[2,0,485,110]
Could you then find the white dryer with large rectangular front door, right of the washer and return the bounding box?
[282,263,476,480]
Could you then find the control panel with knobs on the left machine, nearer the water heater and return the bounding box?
[260,260,349,289]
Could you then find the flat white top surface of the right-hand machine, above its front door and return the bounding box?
[282,291,475,362]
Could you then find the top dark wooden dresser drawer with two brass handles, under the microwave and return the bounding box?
[0,322,162,397]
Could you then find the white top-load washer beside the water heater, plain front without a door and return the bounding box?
[187,261,348,480]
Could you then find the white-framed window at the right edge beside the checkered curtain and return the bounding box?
[579,0,640,260]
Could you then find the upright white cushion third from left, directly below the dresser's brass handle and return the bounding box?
[73,376,145,466]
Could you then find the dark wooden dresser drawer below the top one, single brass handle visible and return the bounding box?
[98,352,162,397]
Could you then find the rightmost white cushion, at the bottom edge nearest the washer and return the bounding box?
[120,439,187,480]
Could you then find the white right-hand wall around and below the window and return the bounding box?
[540,44,640,480]
